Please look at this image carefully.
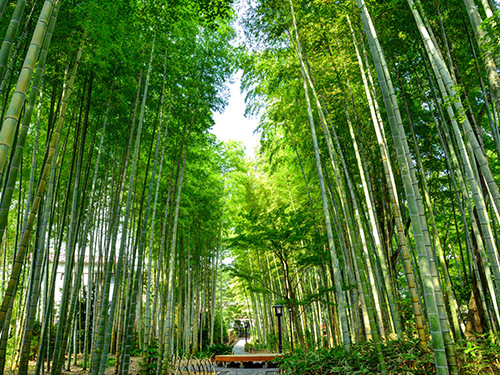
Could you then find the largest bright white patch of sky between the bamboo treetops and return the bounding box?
[212,71,259,158]
